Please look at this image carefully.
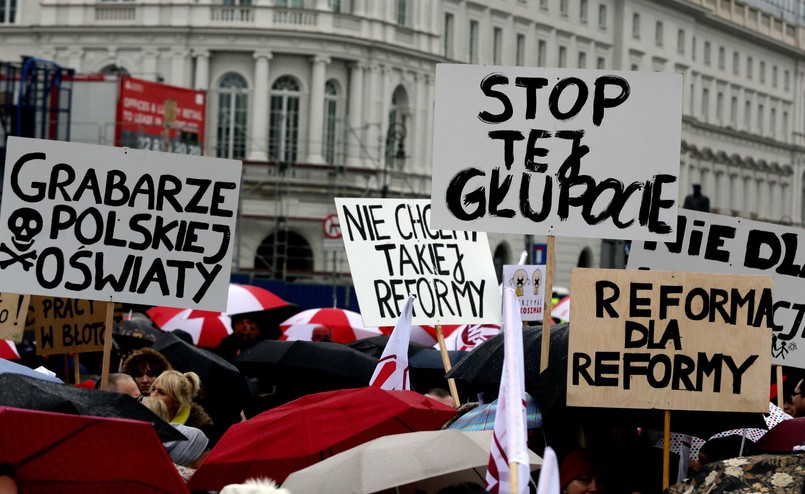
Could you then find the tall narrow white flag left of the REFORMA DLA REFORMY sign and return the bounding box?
[486,287,531,494]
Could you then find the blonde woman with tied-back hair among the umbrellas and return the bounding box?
[151,370,213,434]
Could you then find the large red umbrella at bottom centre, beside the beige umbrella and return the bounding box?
[188,387,456,490]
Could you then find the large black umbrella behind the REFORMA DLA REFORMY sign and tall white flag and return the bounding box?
[447,323,767,437]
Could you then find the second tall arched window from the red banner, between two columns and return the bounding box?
[268,75,301,165]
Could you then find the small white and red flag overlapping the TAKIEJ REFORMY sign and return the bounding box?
[369,295,414,391]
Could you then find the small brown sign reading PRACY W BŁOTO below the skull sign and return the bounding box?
[26,296,111,355]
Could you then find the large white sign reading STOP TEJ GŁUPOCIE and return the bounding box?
[432,64,682,240]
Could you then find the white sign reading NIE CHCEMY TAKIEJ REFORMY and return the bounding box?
[335,199,500,326]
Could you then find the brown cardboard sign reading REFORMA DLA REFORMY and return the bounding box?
[567,268,773,412]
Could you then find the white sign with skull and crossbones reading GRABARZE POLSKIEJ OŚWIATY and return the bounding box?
[0,137,241,311]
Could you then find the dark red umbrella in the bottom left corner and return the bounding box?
[0,407,188,494]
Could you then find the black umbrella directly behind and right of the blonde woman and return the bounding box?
[151,331,250,440]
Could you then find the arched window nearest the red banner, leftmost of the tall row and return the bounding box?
[215,72,249,159]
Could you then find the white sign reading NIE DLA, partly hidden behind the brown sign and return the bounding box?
[627,209,805,369]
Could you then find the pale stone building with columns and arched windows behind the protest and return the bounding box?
[0,0,805,292]
